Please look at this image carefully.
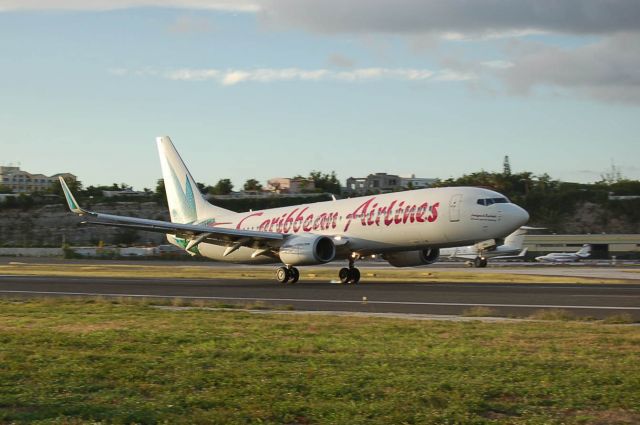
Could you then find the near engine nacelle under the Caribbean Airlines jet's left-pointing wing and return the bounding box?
[279,232,336,266]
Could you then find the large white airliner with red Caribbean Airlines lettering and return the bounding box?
[60,136,529,284]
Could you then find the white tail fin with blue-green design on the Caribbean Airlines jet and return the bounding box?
[156,136,233,223]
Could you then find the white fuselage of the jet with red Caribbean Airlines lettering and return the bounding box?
[168,187,529,263]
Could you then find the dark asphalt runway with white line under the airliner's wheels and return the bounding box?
[0,275,640,319]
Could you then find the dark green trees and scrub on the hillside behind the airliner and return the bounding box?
[0,171,640,246]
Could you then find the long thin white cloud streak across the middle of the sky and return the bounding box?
[136,68,456,86]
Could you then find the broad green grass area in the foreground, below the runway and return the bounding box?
[0,299,640,424]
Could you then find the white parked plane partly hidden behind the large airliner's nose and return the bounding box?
[440,226,542,267]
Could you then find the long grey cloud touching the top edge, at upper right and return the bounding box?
[261,0,640,35]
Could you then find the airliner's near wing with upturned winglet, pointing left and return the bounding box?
[60,177,286,253]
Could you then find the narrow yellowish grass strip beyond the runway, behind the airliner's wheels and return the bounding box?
[0,263,637,284]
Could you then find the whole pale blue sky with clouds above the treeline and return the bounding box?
[0,0,640,189]
